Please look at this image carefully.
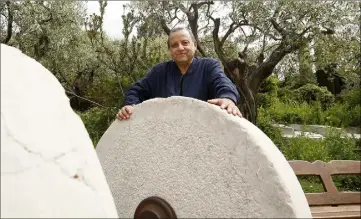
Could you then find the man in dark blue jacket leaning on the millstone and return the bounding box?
[117,28,242,120]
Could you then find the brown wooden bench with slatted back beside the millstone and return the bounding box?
[288,160,361,219]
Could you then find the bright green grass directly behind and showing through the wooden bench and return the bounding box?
[257,112,361,192]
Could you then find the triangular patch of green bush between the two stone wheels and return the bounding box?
[77,107,118,147]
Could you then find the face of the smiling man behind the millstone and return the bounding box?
[169,30,197,63]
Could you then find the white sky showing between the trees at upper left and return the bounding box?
[87,1,129,39]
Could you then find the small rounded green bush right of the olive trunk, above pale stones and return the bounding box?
[295,84,335,109]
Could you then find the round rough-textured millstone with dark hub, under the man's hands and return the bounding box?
[96,97,311,218]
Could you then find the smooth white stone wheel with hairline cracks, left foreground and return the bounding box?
[1,44,118,218]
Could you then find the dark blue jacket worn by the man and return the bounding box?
[125,57,239,105]
